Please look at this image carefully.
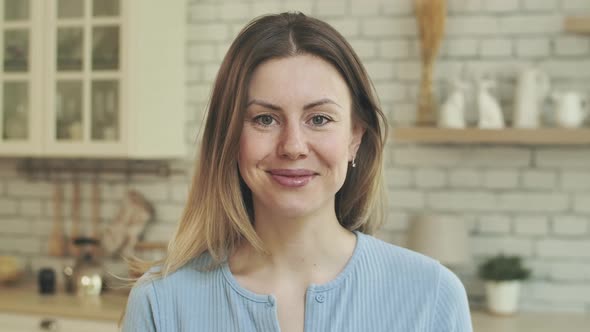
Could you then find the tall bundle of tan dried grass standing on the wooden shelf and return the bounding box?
[414,0,447,125]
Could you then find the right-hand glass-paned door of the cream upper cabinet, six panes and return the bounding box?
[50,0,122,153]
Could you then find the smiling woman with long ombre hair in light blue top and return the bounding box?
[123,13,471,331]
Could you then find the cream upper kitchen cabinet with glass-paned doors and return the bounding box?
[0,0,185,159]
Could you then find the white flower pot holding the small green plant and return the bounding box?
[485,280,520,315]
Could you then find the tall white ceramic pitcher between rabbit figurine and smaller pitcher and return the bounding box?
[513,67,550,128]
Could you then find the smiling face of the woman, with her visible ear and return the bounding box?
[238,55,363,217]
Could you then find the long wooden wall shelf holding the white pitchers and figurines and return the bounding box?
[392,127,590,145]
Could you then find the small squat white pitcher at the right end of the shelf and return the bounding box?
[551,91,590,128]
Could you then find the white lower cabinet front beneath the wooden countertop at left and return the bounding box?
[0,313,119,332]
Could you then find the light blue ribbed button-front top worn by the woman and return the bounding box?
[123,232,472,332]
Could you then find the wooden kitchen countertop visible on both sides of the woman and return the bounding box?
[0,287,590,332]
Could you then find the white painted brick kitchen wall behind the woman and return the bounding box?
[0,0,590,311]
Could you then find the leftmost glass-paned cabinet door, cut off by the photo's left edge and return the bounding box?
[0,0,33,146]
